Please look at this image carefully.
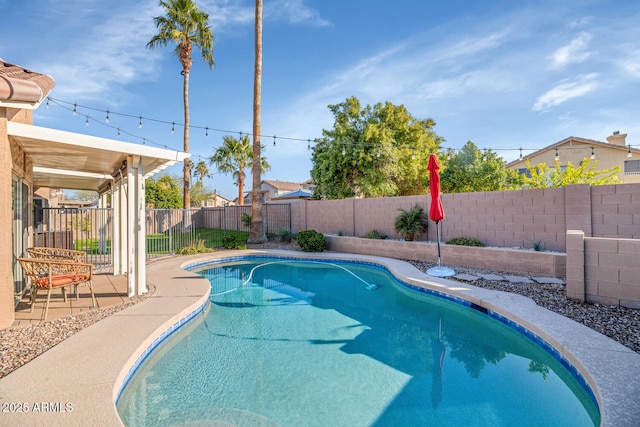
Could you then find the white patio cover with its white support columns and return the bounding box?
[7,122,189,296]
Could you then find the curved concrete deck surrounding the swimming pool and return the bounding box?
[0,250,640,427]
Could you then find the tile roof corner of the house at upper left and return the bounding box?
[0,58,56,104]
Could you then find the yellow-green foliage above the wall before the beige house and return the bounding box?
[522,158,620,188]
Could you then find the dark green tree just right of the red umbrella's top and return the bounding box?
[440,141,523,193]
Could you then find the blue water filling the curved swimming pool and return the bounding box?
[117,257,600,426]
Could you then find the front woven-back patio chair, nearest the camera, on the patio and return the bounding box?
[18,258,96,320]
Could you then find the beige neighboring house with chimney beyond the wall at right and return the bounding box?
[507,132,640,183]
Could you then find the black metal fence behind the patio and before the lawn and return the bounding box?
[34,204,291,268]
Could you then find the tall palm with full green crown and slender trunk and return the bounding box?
[147,0,214,209]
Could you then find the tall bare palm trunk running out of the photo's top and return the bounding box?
[249,0,267,243]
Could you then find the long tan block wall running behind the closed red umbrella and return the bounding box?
[284,184,640,252]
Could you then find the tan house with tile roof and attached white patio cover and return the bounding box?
[0,59,189,329]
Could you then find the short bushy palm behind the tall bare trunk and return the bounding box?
[209,135,271,206]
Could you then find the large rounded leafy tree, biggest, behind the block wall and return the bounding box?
[311,97,443,199]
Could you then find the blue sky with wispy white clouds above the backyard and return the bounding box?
[0,0,640,198]
